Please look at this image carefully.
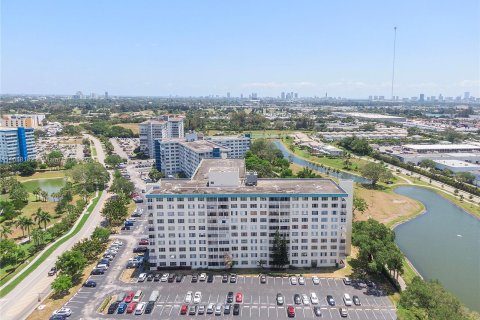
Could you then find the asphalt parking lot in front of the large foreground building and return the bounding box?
[90,275,396,320]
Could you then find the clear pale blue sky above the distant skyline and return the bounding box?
[0,0,480,98]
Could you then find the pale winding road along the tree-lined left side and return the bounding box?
[0,135,109,320]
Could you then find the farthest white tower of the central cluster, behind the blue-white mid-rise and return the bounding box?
[138,115,185,158]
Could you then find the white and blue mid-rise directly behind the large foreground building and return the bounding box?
[155,132,250,177]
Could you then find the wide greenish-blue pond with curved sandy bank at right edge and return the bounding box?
[394,186,480,311]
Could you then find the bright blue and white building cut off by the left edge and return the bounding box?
[0,127,36,163]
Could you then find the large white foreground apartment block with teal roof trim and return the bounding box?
[146,159,353,269]
